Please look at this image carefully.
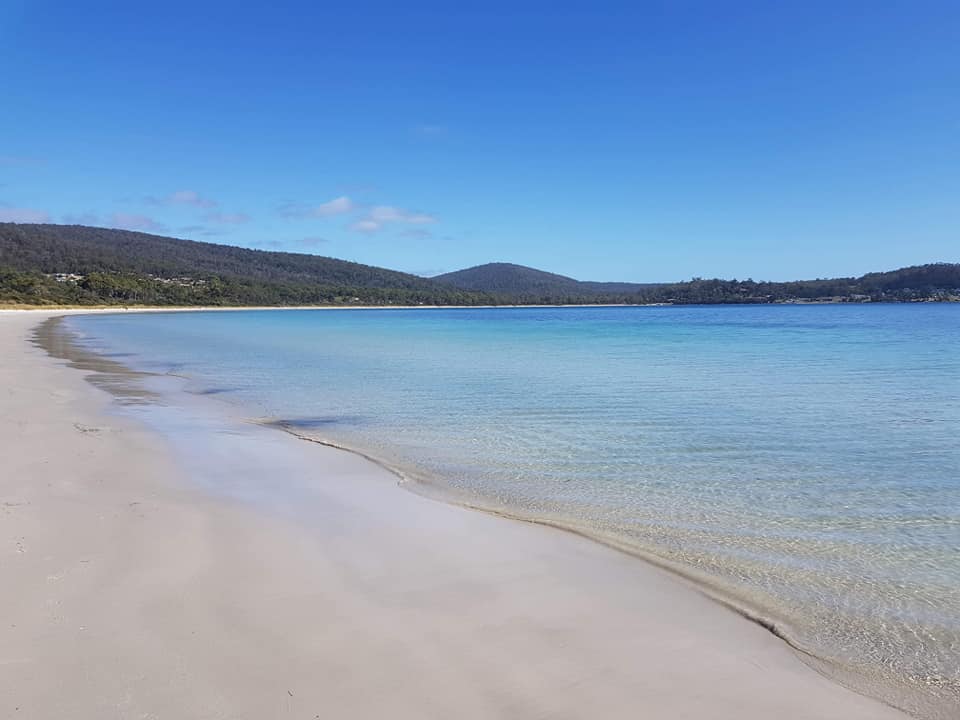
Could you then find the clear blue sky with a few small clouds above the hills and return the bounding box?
[0,0,960,281]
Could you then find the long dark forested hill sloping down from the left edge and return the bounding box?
[0,223,491,305]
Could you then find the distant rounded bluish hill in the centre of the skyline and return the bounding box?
[433,263,657,297]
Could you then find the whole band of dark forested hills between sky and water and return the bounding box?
[0,223,960,306]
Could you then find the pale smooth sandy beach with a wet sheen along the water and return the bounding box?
[0,311,905,720]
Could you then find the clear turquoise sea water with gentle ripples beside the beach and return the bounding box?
[66,304,960,717]
